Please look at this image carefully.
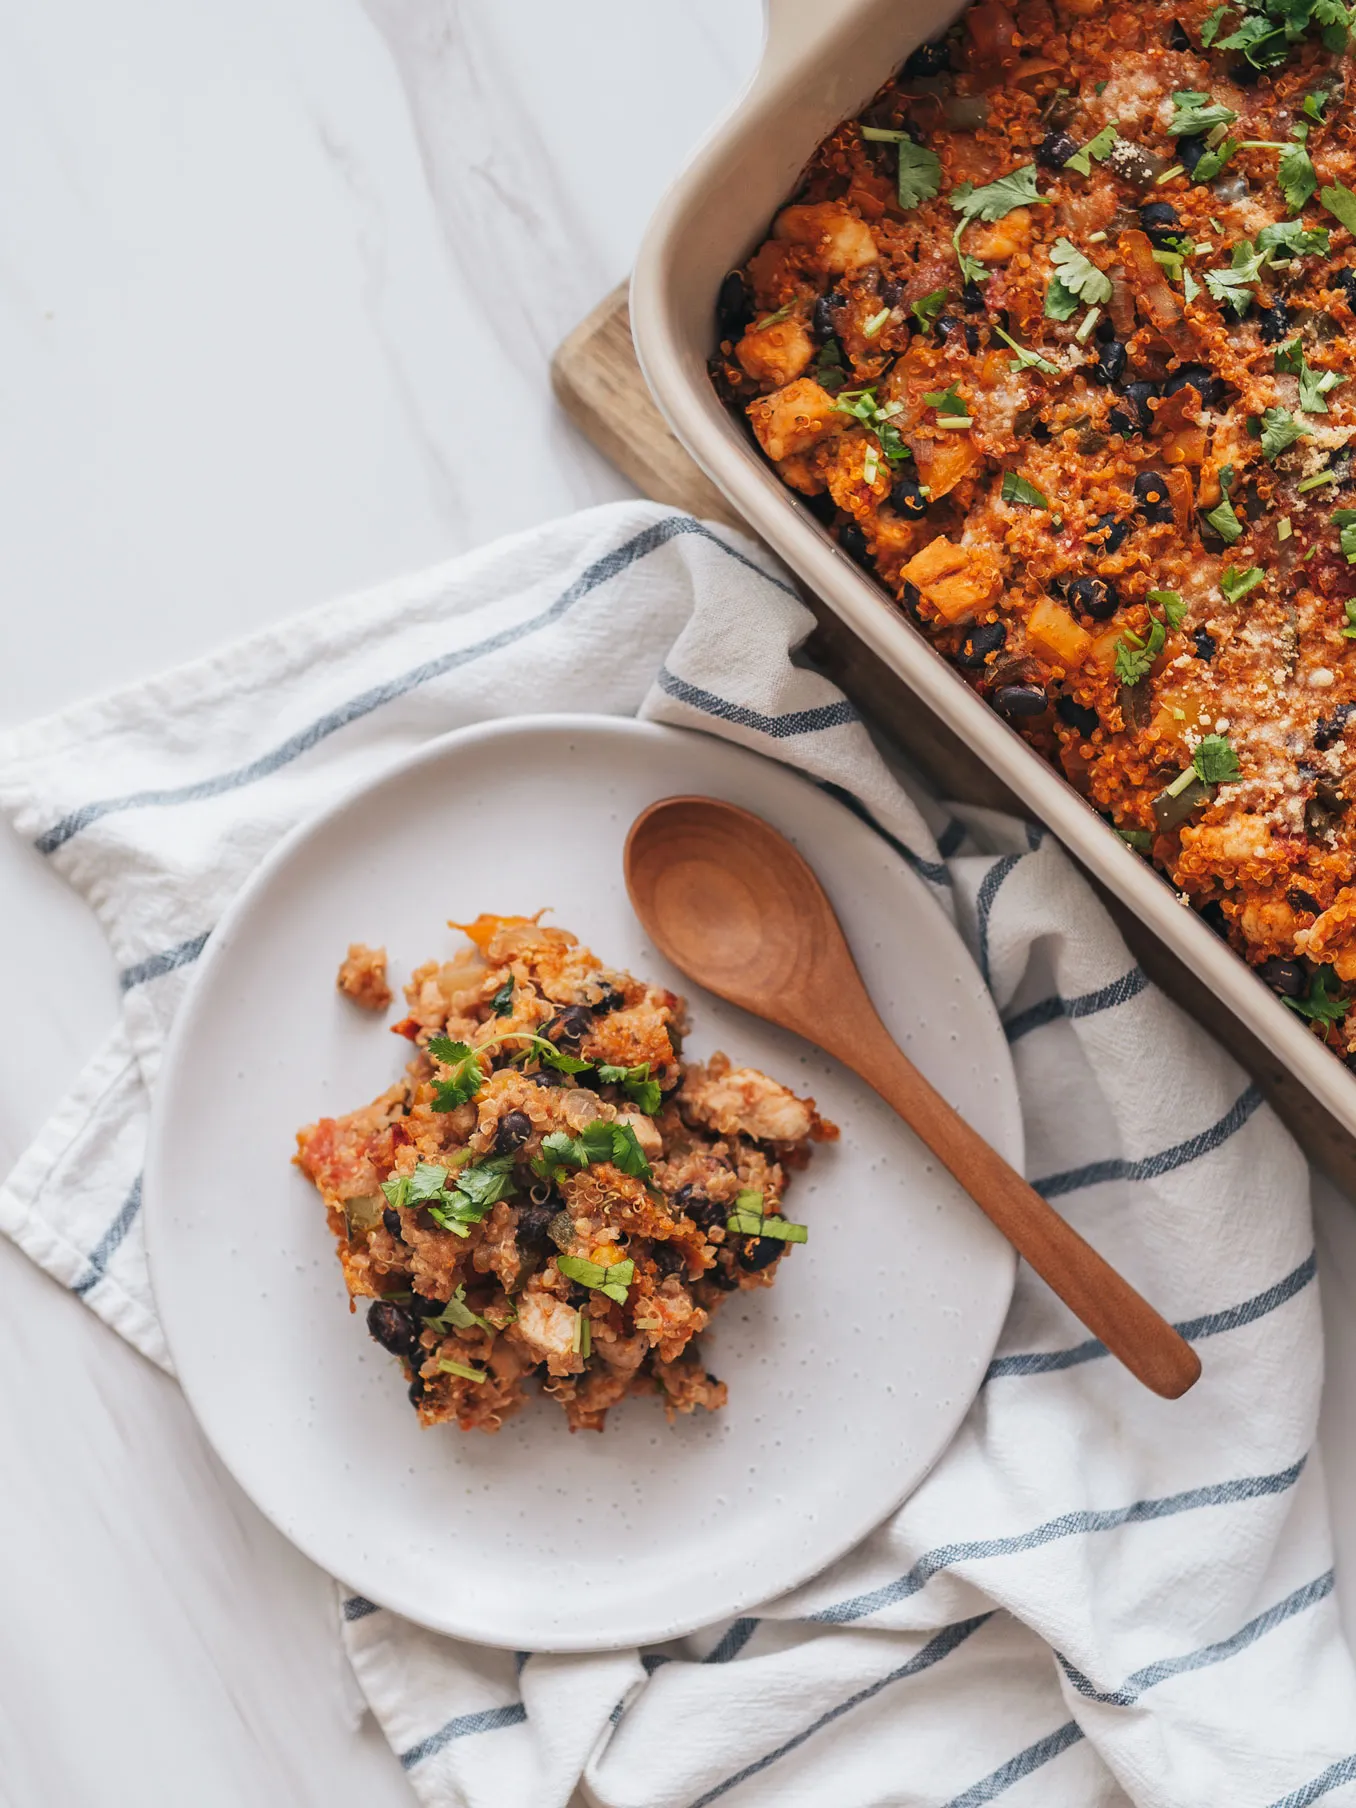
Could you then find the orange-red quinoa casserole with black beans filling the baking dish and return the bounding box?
[712,0,1356,1065]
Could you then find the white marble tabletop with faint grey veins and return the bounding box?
[0,0,1356,1808]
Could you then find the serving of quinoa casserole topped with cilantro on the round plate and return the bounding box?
[297,917,837,1432]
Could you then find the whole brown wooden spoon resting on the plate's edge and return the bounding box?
[626,797,1201,1399]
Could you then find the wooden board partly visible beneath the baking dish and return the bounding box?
[551,284,1356,1191]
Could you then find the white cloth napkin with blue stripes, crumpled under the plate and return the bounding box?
[0,503,1356,1808]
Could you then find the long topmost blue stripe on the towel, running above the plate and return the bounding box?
[34,515,773,853]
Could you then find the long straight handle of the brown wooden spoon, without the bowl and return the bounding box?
[835,1025,1201,1399]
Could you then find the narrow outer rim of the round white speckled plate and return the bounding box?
[143,711,1025,1654]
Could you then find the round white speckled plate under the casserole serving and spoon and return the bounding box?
[146,716,1022,1651]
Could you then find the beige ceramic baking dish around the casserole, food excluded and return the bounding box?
[631,0,1356,1135]
